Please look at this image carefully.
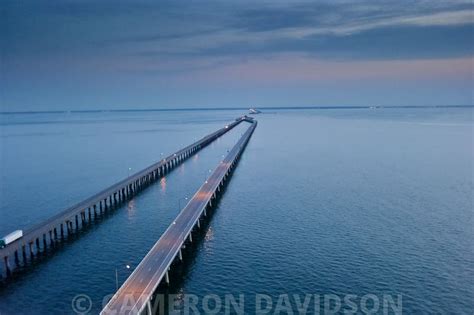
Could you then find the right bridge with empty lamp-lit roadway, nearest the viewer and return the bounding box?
[100,118,257,315]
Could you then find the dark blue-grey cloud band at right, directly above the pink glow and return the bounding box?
[187,25,474,60]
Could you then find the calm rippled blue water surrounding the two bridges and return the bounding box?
[0,108,474,315]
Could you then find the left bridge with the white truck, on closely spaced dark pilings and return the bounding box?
[0,116,252,279]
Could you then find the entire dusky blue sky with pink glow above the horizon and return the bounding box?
[0,0,474,111]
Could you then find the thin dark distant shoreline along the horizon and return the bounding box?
[0,105,474,115]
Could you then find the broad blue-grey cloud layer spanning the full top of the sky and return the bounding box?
[0,0,474,73]
